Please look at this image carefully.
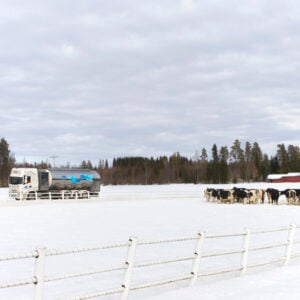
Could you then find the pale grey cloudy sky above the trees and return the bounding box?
[0,0,300,164]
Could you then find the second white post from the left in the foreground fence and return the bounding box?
[121,237,137,300]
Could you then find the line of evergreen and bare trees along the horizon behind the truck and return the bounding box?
[0,138,300,186]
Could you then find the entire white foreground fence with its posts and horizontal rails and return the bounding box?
[0,224,300,300]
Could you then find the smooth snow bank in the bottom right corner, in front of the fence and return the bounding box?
[144,264,300,300]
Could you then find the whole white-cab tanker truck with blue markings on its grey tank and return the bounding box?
[9,168,100,200]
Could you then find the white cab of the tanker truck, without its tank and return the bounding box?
[9,168,39,199]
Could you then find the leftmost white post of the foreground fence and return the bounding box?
[34,248,46,300]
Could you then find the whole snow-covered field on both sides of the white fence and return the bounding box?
[0,183,300,300]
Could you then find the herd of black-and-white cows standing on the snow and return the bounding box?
[204,187,300,205]
